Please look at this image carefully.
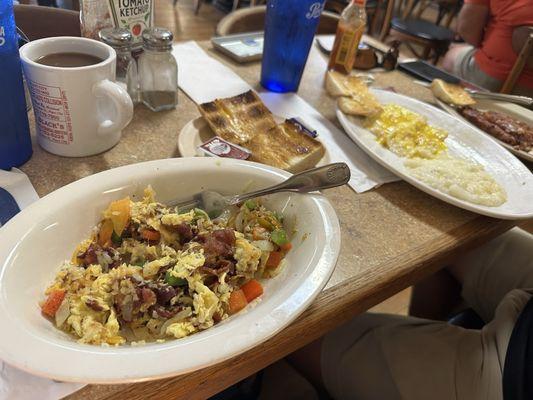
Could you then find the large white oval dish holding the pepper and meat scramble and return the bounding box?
[0,158,340,383]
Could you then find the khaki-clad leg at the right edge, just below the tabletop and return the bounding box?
[448,228,533,322]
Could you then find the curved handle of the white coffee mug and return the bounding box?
[93,79,133,135]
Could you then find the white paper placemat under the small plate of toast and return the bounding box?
[172,42,398,193]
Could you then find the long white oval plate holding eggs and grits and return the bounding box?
[337,89,533,219]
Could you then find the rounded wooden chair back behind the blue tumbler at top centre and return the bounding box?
[216,6,339,36]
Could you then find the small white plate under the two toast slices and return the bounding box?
[178,117,331,167]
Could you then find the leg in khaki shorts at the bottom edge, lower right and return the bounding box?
[321,313,494,400]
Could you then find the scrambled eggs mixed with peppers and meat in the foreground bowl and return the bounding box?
[41,188,285,346]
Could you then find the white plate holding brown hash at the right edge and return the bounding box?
[435,98,533,162]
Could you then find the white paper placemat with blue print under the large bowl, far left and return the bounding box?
[0,168,84,400]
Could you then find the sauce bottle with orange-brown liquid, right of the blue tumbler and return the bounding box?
[328,0,366,74]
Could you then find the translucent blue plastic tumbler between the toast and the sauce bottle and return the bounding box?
[261,0,325,92]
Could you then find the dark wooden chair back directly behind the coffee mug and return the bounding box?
[14,4,81,40]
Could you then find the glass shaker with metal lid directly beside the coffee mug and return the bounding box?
[98,28,140,104]
